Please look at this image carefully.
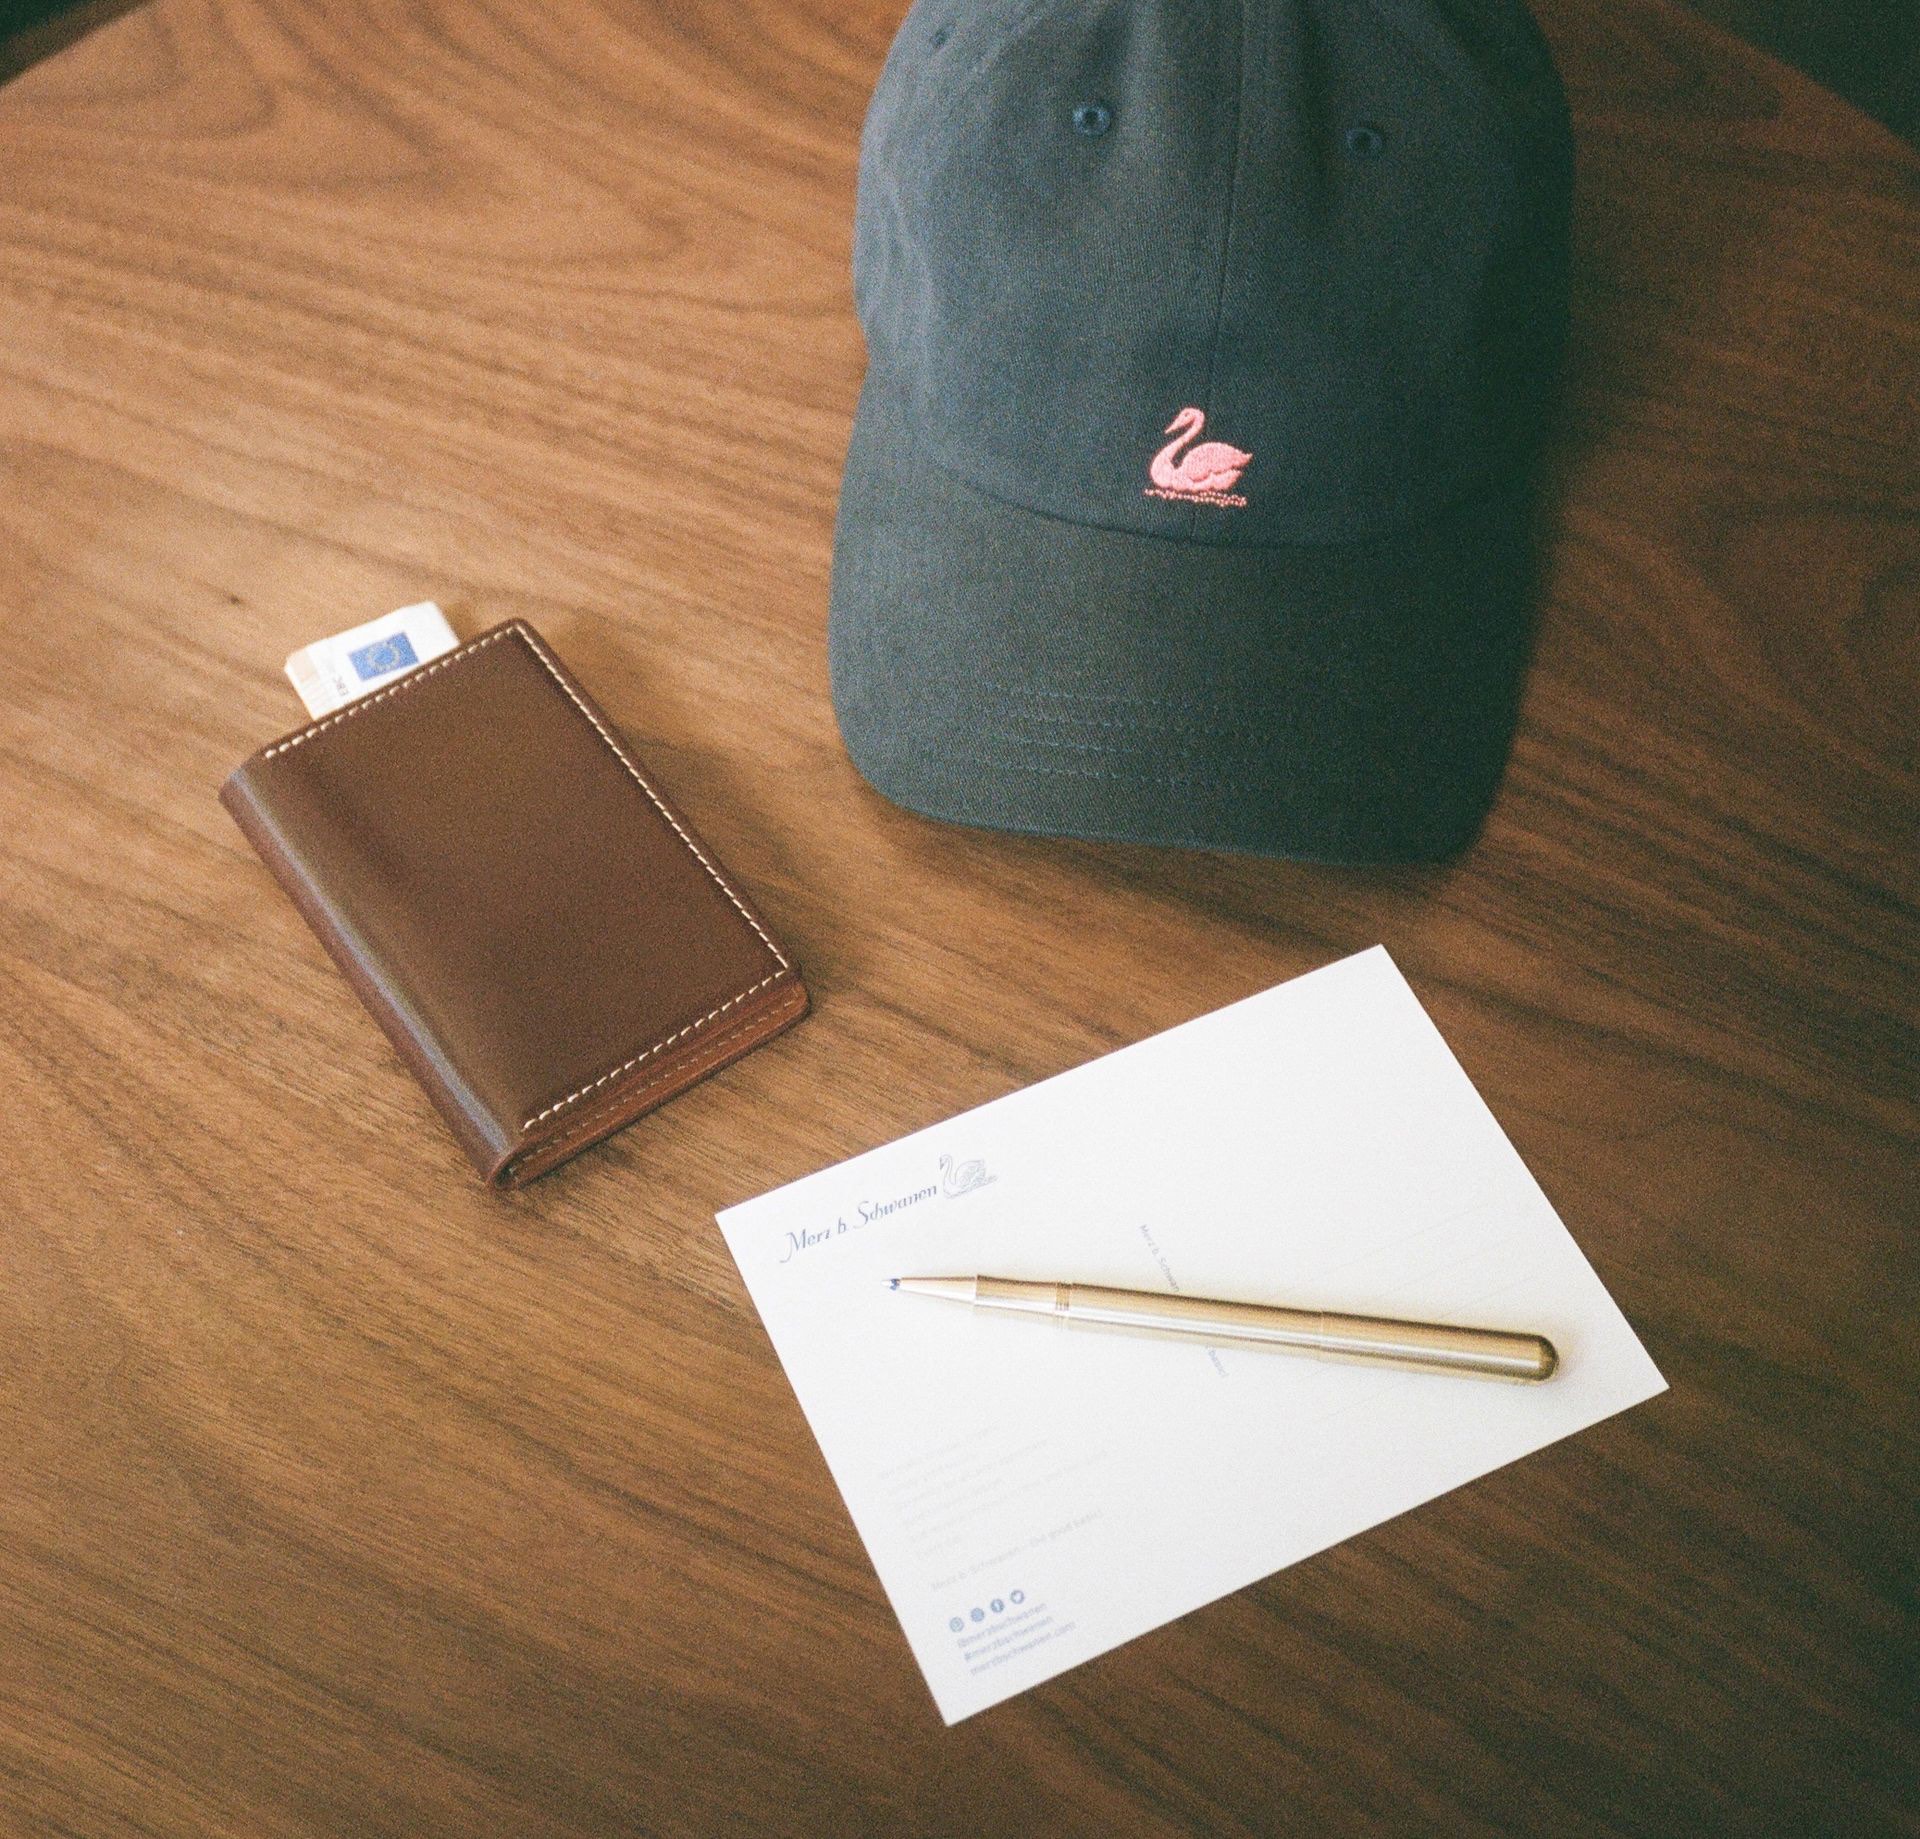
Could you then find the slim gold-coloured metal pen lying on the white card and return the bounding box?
[889,1277,1559,1380]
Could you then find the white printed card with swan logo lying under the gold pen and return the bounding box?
[720,948,1665,1724]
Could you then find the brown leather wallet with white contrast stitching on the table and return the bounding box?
[221,620,806,1186]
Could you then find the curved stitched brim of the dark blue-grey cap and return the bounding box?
[829,372,1532,862]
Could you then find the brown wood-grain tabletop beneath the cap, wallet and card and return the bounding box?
[0,0,1920,1839]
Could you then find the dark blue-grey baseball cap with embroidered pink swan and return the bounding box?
[829,0,1572,862]
